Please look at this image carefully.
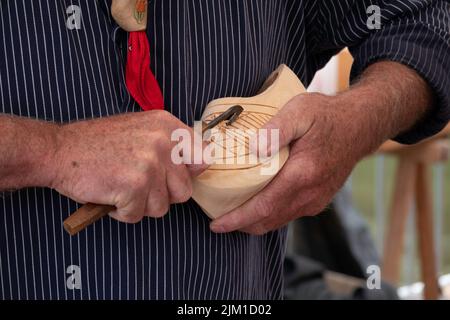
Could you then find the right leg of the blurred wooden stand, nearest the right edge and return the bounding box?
[416,163,439,299]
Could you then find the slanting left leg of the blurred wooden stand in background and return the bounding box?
[383,157,416,284]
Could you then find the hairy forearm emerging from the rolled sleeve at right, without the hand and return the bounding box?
[336,62,433,155]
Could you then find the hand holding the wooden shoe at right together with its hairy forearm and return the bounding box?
[211,62,432,235]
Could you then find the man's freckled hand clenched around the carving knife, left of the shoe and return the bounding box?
[48,111,206,223]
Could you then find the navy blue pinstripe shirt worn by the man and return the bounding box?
[0,0,450,299]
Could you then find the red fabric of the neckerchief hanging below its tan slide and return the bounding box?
[125,31,164,111]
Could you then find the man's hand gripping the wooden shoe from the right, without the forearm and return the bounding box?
[211,94,374,235]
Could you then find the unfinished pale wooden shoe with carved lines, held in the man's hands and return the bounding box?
[192,65,306,219]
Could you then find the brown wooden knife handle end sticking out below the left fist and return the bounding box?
[64,203,116,236]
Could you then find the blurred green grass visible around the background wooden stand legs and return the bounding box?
[351,157,450,283]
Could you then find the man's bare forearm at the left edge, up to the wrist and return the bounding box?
[0,115,58,191]
